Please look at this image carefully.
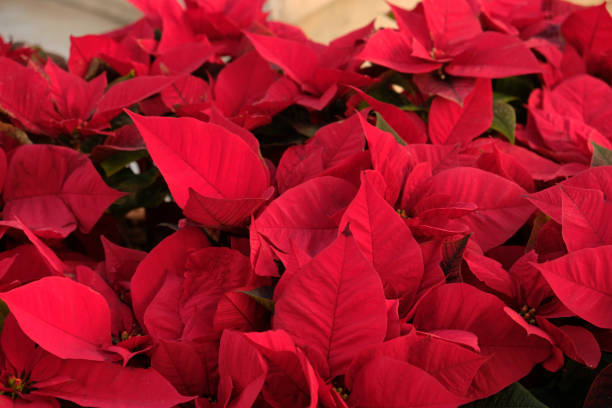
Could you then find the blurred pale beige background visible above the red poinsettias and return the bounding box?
[0,0,604,56]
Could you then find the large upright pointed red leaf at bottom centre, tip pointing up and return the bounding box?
[273,234,387,377]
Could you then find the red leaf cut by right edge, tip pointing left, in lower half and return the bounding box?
[532,245,612,329]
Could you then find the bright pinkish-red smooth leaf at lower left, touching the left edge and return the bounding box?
[0,277,111,361]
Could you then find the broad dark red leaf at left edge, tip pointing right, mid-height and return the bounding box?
[4,145,124,237]
